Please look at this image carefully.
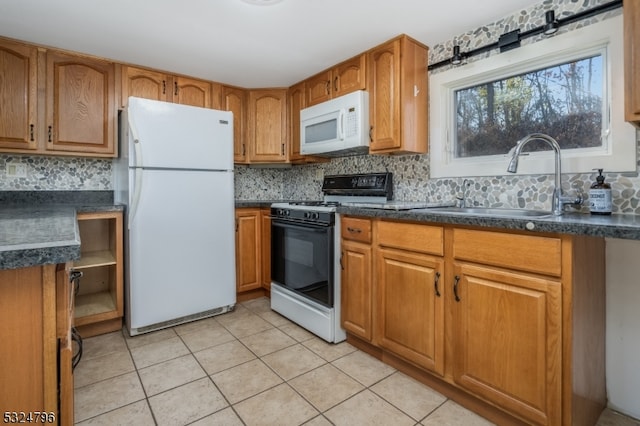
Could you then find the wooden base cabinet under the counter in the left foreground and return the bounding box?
[0,264,73,425]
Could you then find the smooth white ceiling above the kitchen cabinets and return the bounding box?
[0,0,539,88]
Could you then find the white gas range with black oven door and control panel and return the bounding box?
[271,173,436,343]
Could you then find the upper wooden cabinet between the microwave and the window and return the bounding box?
[367,35,429,154]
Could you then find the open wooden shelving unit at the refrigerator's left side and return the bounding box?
[73,211,123,337]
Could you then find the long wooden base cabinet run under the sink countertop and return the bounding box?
[342,216,606,425]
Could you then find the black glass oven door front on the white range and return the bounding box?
[271,220,333,307]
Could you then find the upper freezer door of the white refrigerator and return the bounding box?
[125,97,233,170]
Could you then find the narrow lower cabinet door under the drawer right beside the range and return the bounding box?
[340,239,373,341]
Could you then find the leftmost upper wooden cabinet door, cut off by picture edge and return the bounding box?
[0,41,40,150]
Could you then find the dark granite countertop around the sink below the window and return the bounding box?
[337,207,640,240]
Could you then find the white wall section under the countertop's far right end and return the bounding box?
[606,239,640,419]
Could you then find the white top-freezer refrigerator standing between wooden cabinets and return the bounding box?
[113,97,236,336]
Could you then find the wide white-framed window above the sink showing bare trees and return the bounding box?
[430,16,636,177]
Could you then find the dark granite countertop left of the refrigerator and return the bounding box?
[0,191,124,269]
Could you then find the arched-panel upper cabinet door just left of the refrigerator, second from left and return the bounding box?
[46,51,117,156]
